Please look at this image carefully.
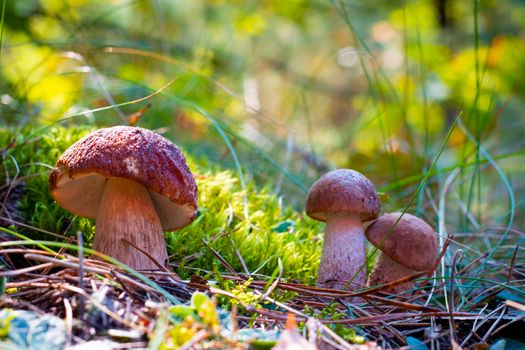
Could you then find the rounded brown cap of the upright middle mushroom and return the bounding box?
[306,169,381,221]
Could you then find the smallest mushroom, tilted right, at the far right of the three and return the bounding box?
[366,213,438,294]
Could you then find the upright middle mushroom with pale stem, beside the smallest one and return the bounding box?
[306,169,381,289]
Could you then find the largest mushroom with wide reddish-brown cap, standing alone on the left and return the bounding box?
[49,126,197,270]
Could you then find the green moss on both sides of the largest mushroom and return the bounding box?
[0,127,322,283]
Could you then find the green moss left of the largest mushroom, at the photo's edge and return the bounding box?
[0,127,94,244]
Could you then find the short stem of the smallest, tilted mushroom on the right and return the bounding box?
[367,253,417,294]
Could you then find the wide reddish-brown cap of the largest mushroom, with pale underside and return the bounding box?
[49,126,197,231]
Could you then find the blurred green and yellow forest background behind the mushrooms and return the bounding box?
[0,0,525,241]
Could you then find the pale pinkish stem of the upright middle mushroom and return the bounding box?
[317,215,366,290]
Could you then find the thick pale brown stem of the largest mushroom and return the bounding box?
[93,178,168,270]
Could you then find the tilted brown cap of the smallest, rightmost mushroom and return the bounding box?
[365,213,438,271]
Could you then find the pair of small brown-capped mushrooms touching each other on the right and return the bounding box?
[306,169,438,293]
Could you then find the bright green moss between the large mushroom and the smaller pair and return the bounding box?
[168,167,320,282]
